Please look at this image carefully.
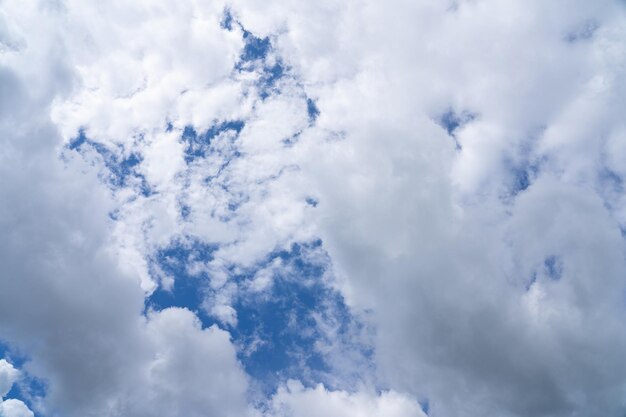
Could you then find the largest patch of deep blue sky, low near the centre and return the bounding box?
[232,240,371,392]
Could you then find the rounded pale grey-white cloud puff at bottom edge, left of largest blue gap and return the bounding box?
[130,309,257,417]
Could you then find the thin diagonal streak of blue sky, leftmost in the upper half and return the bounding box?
[68,129,153,196]
